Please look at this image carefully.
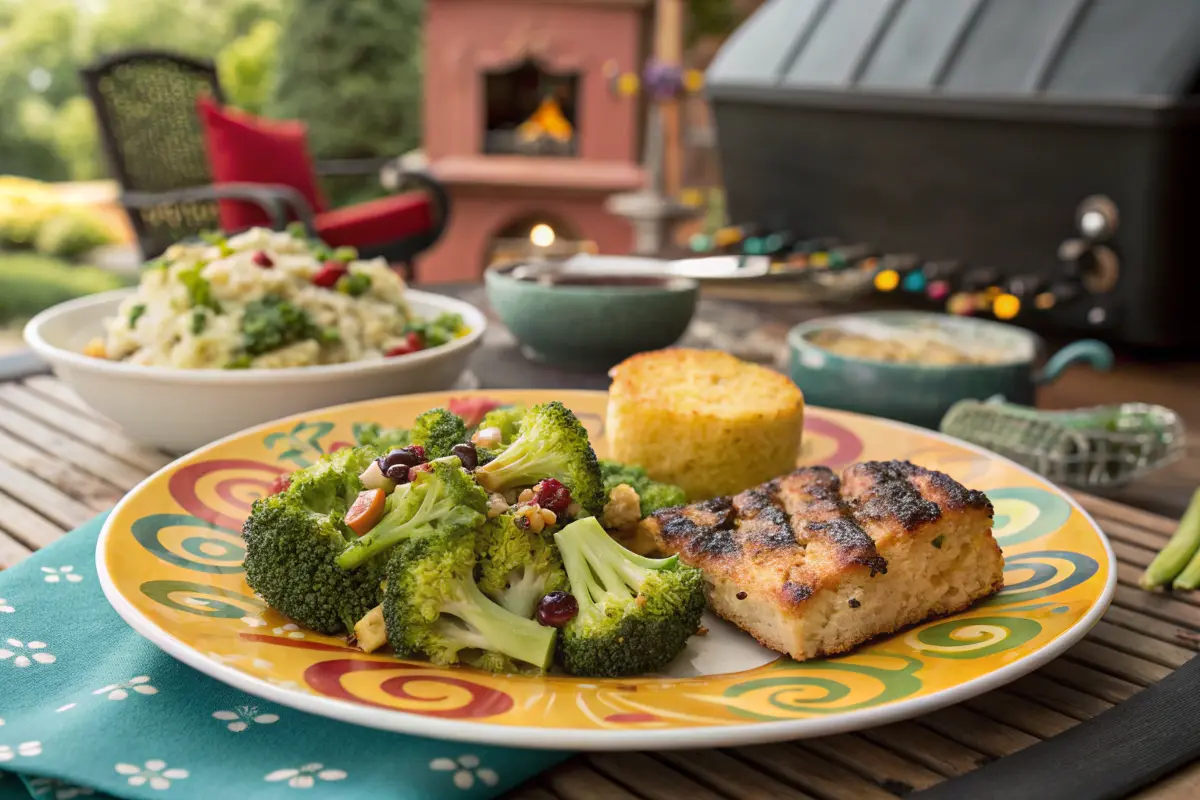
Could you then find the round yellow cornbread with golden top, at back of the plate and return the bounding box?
[606,348,804,500]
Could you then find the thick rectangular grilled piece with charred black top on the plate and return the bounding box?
[642,461,1004,661]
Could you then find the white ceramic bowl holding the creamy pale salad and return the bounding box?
[25,289,487,453]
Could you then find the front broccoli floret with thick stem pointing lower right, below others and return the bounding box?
[383,533,556,672]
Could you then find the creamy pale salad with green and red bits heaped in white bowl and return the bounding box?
[85,228,468,369]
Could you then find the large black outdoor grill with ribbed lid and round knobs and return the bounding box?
[707,0,1200,345]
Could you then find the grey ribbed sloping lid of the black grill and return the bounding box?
[707,0,1200,117]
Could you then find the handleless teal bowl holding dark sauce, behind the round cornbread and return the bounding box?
[484,267,698,368]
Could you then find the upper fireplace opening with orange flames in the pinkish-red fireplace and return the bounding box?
[484,60,580,157]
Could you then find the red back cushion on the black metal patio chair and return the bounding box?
[197,97,326,231]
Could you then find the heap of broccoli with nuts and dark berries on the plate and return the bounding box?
[242,401,704,678]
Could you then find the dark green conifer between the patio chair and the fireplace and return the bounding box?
[270,0,427,164]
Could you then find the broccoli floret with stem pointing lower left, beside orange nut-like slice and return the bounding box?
[337,457,487,570]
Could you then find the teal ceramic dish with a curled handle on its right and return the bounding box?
[787,312,1112,429]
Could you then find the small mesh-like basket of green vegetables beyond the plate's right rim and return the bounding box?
[940,398,1186,491]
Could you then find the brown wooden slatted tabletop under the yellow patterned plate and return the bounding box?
[0,375,1200,800]
